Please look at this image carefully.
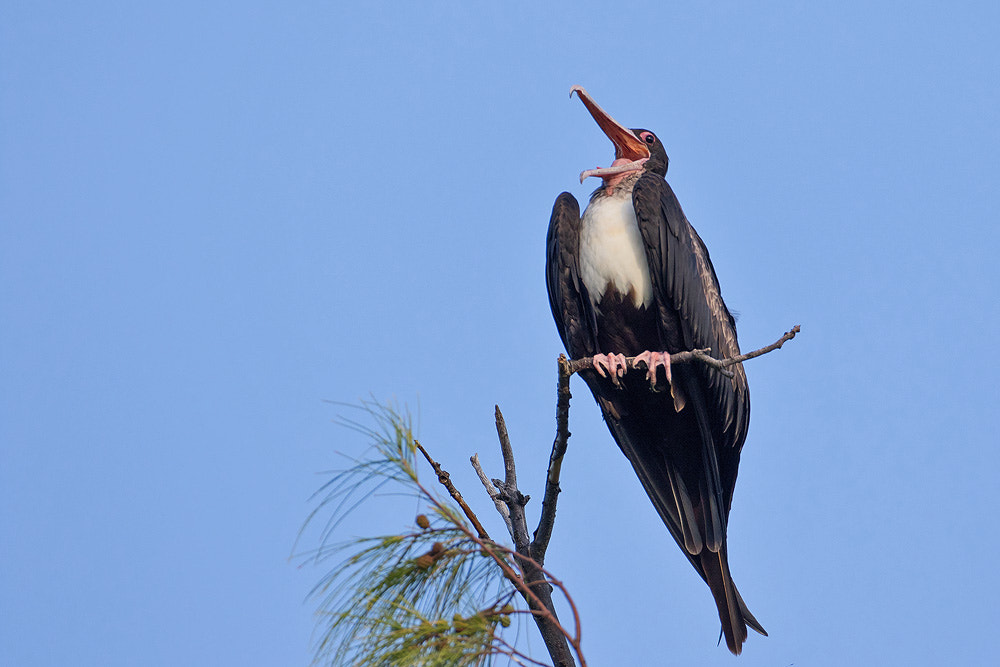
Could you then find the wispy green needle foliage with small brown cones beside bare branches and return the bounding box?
[303,403,515,667]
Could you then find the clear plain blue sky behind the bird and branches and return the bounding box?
[0,1,1000,667]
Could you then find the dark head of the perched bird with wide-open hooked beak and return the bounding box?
[569,86,669,189]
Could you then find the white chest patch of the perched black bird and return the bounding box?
[580,196,653,307]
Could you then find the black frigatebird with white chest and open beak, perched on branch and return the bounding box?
[545,86,767,655]
